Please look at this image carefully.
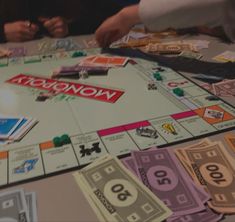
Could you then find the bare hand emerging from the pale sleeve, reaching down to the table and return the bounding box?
[95,5,140,47]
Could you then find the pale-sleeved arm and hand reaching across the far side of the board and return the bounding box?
[95,0,235,47]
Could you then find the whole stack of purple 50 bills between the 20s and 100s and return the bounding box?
[122,148,222,222]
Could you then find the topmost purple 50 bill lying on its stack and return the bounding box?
[132,149,205,216]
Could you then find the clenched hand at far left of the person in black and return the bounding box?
[4,21,38,42]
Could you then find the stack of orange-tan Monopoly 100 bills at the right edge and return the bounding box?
[175,140,235,214]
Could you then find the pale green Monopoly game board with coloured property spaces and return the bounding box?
[0,49,235,187]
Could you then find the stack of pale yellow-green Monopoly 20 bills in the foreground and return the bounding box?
[74,155,171,222]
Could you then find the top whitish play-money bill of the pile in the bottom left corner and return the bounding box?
[0,189,29,222]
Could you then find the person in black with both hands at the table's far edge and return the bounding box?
[0,0,122,42]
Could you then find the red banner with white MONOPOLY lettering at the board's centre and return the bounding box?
[6,74,124,103]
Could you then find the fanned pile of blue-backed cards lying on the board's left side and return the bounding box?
[0,115,38,144]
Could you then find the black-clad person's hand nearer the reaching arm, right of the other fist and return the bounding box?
[39,16,69,38]
